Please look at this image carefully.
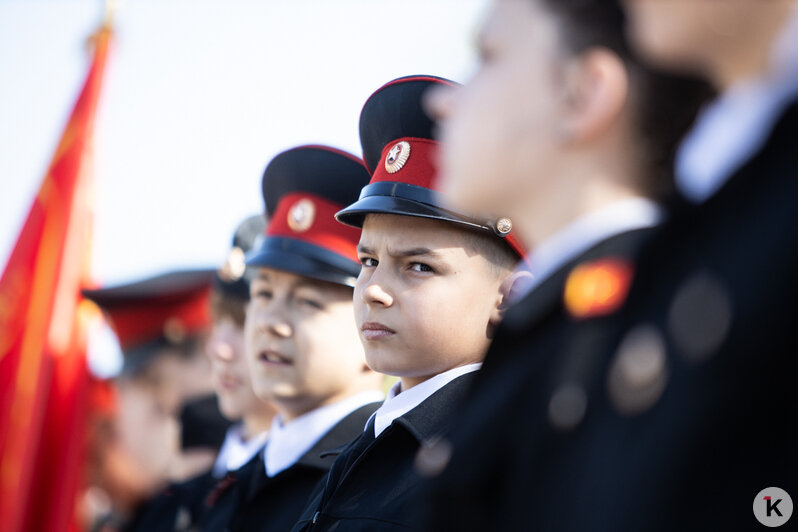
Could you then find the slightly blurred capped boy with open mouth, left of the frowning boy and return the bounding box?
[203,146,383,532]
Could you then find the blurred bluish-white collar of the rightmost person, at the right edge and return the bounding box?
[676,9,798,203]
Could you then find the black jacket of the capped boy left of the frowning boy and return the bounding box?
[200,403,380,532]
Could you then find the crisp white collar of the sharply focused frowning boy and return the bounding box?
[366,363,482,437]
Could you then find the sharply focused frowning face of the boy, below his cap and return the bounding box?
[354,214,518,389]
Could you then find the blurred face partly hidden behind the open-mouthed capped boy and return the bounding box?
[207,290,274,430]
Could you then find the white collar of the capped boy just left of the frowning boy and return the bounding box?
[263,390,383,477]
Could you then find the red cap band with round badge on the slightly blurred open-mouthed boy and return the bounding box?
[266,192,360,262]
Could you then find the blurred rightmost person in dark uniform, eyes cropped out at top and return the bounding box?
[568,0,798,530]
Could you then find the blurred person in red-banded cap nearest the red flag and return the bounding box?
[84,270,227,521]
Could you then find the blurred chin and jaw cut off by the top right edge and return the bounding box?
[624,0,796,88]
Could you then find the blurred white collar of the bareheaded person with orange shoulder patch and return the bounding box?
[511,197,665,303]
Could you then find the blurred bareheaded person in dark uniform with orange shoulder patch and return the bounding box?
[425,0,707,530]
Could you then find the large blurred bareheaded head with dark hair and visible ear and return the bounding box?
[429,0,705,246]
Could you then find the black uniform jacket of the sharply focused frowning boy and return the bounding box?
[293,373,474,532]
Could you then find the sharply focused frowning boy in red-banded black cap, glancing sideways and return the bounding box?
[294,76,520,531]
